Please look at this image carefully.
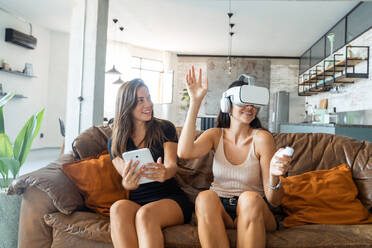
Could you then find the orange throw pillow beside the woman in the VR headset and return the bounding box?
[282,164,372,227]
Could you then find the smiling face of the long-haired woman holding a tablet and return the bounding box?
[132,87,153,122]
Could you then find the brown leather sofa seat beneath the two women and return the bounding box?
[44,212,372,248]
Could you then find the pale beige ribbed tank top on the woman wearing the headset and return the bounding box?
[210,129,264,198]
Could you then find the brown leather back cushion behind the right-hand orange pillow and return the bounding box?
[273,133,372,209]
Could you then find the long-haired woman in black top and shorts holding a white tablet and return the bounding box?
[108,79,192,248]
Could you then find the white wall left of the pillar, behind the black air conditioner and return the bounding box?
[0,11,68,148]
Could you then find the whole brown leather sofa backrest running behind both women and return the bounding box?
[73,126,372,208]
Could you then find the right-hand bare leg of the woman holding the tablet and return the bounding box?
[136,199,184,248]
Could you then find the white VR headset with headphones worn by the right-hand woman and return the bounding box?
[220,74,269,113]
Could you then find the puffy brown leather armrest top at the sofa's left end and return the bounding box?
[8,154,84,214]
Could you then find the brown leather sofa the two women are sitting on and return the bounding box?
[9,127,372,248]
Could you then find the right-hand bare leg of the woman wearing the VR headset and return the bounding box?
[236,191,276,248]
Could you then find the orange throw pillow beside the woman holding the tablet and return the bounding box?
[62,154,129,216]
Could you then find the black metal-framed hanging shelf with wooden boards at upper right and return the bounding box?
[298,46,369,96]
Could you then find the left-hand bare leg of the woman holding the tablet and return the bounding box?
[110,200,141,248]
